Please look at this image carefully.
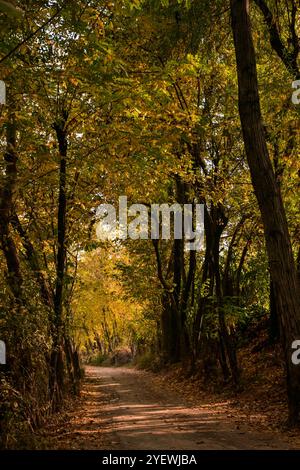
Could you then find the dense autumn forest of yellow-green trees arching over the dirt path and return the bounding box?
[0,0,300,447]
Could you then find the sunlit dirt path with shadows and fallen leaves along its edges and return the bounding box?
[45,367,292,450]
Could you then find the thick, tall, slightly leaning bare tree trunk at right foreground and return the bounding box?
[230,0,300,424]
